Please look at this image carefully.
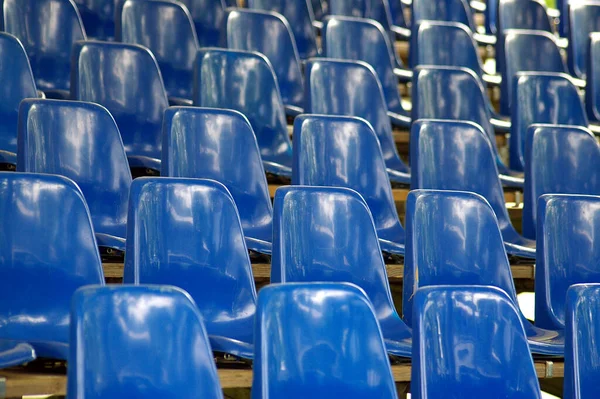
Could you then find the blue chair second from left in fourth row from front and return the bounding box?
[72,42,169,171]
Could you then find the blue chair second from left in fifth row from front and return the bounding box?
[118,0,199,99]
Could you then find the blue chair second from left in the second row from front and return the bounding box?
[123,178,256,359]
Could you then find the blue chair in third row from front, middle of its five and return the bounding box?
[292,115,404,255]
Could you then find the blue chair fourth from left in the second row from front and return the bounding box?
[402,190,564,355]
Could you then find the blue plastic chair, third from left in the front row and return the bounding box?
[411,286,542,399]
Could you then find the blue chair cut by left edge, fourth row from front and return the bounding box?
[0,33,38,169]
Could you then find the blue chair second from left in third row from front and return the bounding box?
[161,107,273,254]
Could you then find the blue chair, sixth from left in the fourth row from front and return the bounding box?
[509,72,588,170]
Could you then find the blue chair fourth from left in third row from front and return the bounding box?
[410,120,535,259]
